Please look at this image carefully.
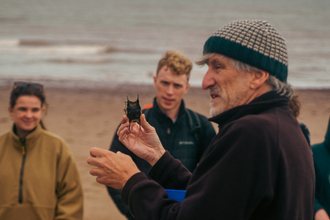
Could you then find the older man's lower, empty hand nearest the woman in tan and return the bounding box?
[87,147,140,189]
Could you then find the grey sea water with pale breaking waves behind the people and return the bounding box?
[0,0,330,88]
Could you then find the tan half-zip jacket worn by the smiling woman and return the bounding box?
[0,125,83,220]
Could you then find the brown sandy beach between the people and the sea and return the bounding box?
[0,85,330,220]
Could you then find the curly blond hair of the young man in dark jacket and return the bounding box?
[156,50,192,81]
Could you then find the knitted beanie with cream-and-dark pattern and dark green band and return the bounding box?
[203,20,288,82]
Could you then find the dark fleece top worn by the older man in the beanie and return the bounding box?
[122,92,315,220]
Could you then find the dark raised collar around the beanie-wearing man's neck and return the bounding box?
[209,91,289,126]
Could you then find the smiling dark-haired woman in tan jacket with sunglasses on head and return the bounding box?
[0,82,83,220]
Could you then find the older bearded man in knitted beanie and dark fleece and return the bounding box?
[87,20,315,220]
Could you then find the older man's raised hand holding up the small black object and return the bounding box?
[117,114,165,166]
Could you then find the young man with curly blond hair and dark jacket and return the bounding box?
[107,51,215,219]
